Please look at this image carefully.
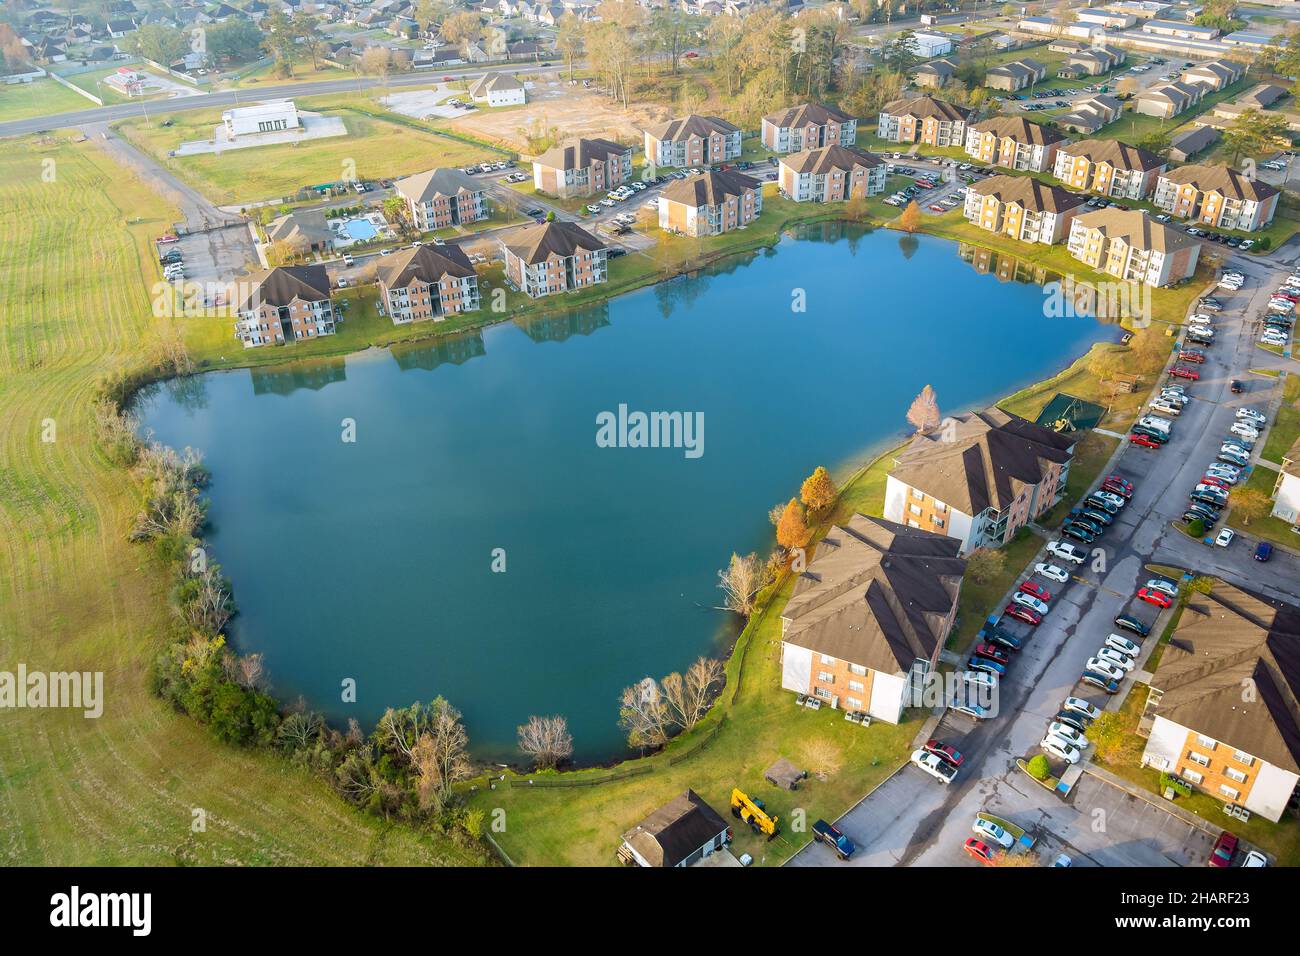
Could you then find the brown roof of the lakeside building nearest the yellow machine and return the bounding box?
[781,515,966,674]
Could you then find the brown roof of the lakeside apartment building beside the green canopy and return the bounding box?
[891,406,1074,515]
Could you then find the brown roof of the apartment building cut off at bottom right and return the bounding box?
[1152,581,1300,773]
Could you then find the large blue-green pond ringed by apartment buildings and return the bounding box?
[138,224,1118,761]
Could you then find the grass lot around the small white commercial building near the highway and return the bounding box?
[118,95,493,206]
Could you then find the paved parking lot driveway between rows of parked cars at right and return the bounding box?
[790,247,1300,866]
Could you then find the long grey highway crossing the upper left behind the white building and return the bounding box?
[0,64,563,137]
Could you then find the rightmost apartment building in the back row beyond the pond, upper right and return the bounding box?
[1152,165,1279,232]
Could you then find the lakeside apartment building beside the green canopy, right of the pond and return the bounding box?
[884,405,1078,554]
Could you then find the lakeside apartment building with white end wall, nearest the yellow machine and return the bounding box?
[781,515,966,723]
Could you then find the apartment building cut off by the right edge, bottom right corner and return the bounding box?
[1138,580,1300,822]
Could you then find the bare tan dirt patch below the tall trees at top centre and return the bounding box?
[451,79,672,157]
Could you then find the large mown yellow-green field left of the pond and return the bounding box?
[0,140,483,865]
